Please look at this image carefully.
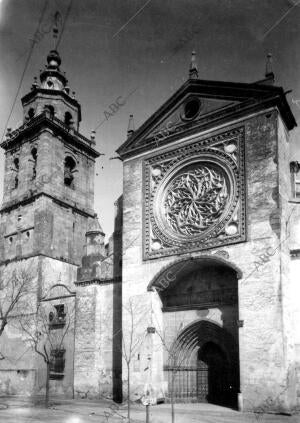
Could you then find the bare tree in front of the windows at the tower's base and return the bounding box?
[18,301,75,407]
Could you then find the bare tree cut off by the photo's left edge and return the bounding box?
[0,265,36,360]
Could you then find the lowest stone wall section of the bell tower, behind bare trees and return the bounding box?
[0,256,77,397]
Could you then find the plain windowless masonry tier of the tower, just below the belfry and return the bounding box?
[0,197,92,264]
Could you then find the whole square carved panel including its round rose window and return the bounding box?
[144,127,246,260]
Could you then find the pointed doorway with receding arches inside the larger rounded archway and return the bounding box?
[165,320,239,406]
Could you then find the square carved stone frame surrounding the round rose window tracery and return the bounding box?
[143,127,246,260]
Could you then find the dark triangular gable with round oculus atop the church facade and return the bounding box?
[117,79,297,159]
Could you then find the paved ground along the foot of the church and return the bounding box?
[0,398,300,423]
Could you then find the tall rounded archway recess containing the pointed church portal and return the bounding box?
[152,257,239,406]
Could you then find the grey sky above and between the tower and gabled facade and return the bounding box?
[0,0,300,235]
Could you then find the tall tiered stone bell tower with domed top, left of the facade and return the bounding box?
[0,46,99,396]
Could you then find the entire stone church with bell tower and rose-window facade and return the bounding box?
[0,50,300,412]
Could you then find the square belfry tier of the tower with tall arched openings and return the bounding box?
[2,129,94,215]
